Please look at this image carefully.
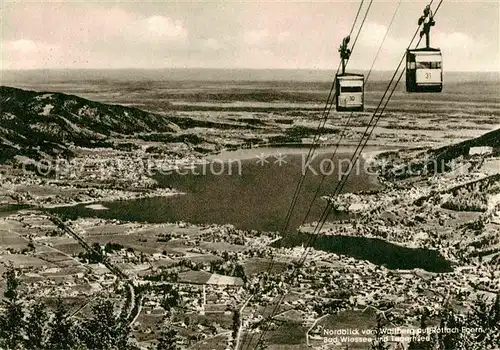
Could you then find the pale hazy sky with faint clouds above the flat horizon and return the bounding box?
[0,0,500,71]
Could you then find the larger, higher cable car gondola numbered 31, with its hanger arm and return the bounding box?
[406,5,443,92]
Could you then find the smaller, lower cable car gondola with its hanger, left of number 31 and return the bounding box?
[335,36,365,112]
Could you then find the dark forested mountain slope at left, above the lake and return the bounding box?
[0,86,178,161]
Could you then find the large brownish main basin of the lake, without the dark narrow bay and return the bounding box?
[49,148,382,232]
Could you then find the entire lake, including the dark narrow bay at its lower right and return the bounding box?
[51,148,450,272]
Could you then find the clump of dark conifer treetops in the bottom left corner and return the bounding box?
[0,265,138,350]
